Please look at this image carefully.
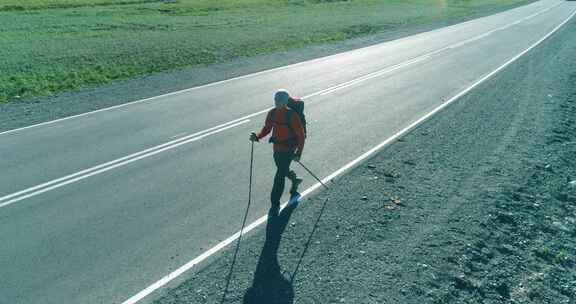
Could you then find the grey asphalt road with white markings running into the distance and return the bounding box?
[0,0,576,304]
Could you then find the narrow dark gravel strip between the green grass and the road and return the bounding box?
[0,0,532,132]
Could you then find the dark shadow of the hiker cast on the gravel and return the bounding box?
[244,205,296,304]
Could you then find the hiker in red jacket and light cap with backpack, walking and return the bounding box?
[250,90,306,215]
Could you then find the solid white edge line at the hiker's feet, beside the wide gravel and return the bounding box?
[122,10,576,304]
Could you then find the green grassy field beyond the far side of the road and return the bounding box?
[0,0,531,102]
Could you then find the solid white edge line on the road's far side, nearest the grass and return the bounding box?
[0,3,550,135]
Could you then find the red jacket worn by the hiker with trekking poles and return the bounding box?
[256,107,304,154]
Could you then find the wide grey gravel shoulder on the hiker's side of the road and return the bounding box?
[155,15,576,304]
